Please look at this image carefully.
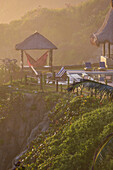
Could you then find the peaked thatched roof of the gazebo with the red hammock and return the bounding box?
[16,32,57,50]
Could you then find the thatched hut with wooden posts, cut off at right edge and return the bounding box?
[90,1,113,68]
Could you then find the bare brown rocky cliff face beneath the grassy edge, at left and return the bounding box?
[0,94,51,170]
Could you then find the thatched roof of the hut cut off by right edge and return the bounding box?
[90,8,113,46]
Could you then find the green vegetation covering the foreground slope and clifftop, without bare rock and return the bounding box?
[0,73,113,170]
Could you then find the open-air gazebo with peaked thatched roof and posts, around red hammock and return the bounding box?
[16,32,57,70]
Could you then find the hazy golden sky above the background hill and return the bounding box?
[0,0,84,23]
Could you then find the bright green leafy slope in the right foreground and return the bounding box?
[17,95,113,170]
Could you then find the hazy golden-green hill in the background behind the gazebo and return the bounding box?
[0,0,109,65]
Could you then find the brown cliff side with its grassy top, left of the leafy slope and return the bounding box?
[0,82,61,170]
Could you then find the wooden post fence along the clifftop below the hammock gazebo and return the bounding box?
[0,68,103,96]
